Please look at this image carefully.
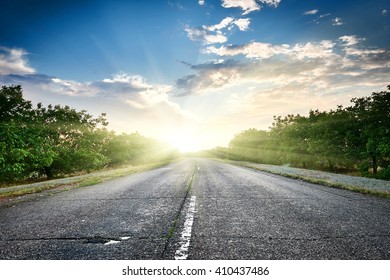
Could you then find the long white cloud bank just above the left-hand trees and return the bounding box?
[0,68,190,117]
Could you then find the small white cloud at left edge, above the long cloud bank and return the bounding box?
[0,46,35,75]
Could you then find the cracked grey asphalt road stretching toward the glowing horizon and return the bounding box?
[0,158,390,260]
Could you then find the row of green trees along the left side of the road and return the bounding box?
[0,85,176,182]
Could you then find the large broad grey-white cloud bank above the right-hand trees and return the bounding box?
[177,35,390,95]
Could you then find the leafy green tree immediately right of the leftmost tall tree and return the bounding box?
[35,104,107,178]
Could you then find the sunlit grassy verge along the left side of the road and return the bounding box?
[0,161,173,200]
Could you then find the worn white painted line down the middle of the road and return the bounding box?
[175,196,196,260]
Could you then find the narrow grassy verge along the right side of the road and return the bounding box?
[217,159,390,199]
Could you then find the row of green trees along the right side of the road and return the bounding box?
[211,86,390,179]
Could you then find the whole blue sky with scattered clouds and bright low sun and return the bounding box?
[0,0,390,151]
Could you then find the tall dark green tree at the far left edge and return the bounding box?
[0,86,53,181]
